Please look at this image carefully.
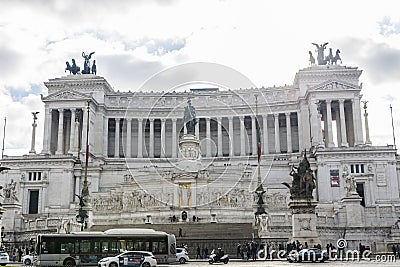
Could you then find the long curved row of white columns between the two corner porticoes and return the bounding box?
[103,112,302,158]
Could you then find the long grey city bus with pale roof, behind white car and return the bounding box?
[36,229,176,266]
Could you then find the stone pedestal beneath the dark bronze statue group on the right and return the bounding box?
[289,199,321,247]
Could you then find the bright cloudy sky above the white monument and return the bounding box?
[0,0,400,155]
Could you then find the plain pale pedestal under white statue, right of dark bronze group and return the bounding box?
[342,192,364,227]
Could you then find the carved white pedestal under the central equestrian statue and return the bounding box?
[176,134,203,172]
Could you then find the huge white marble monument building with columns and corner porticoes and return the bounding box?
[0,50,400,251]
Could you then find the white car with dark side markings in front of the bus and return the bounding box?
[98,251,157,267]
